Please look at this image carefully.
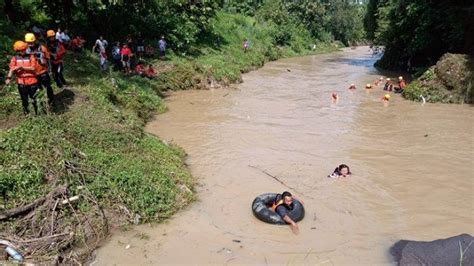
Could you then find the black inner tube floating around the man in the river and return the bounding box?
[252,193,304,224]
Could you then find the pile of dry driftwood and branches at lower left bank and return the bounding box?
[0,180,108,265]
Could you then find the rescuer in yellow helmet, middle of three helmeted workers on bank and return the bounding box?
[25,33,54,104]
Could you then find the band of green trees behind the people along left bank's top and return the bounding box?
[4,0,364,50]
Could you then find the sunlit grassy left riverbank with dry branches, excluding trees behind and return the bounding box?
[0,13,337,263]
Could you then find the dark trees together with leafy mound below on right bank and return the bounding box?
[364,0,474,103]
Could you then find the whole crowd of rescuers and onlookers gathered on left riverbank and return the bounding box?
[5,26,167,115]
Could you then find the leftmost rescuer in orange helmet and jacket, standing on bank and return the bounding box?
[5,41,40,115]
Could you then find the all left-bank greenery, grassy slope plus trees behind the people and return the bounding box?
[0,0,364,263]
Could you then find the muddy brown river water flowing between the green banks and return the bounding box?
[93,47,474,265]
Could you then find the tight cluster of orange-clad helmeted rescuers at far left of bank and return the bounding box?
[5,29,69,114]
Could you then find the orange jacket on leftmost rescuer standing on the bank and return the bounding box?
[10,55,38,85]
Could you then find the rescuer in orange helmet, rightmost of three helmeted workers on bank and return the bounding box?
[46,30,67,88]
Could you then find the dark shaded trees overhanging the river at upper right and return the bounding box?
[364,0,474,70]
